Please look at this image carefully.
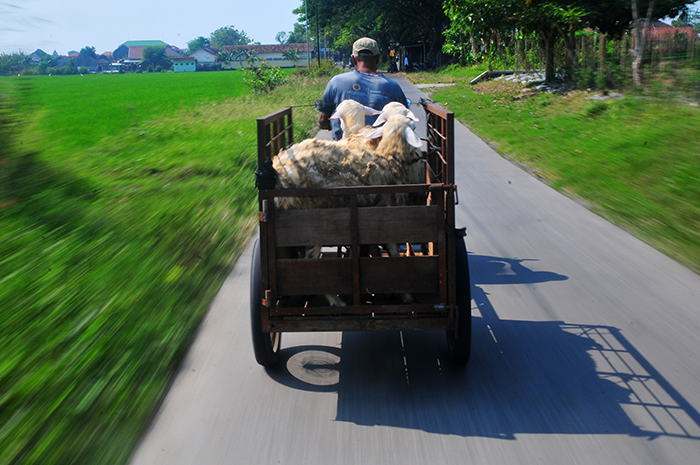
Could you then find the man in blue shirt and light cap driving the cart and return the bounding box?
[316,37,408,140]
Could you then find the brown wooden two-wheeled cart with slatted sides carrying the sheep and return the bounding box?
[250,102,471,367]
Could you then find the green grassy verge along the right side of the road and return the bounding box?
[408,70,700,272]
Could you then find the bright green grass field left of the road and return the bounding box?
[0,73,325,465]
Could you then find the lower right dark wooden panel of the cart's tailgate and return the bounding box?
[360,256,440,294]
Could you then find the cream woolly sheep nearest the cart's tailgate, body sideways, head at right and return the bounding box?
[272,114,422,306]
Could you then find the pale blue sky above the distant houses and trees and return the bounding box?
[0,0,301,55]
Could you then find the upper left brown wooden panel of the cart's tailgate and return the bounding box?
[271,208,351,247]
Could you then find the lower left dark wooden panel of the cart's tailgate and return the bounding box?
[277,258,352,295]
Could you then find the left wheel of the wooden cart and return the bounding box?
[250,240,282,367]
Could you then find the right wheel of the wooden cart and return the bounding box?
[447,237,472,365]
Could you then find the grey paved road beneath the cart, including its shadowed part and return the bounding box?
[132,74,700,465]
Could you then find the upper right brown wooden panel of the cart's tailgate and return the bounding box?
[358,205,440,244]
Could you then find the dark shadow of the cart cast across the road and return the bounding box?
[268,255,700,439]
